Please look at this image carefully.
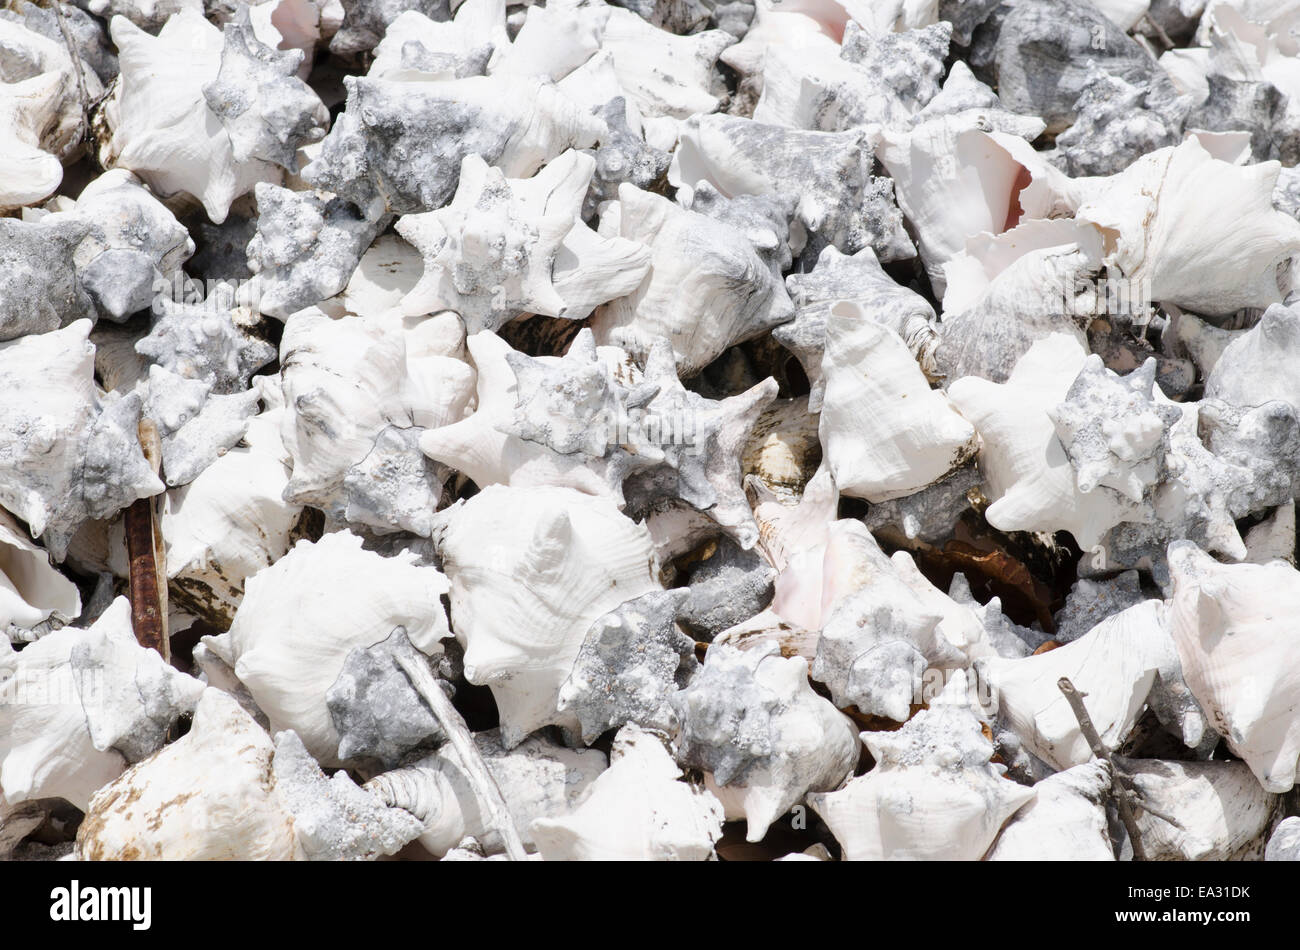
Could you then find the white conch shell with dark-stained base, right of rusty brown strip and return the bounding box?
[163,378,303,629]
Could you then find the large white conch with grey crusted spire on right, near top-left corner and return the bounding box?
[100,10,329,224]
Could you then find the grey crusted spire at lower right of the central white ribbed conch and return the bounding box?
[558,590,699,743]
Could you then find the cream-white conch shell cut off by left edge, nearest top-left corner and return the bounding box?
[0,19,104,211]
